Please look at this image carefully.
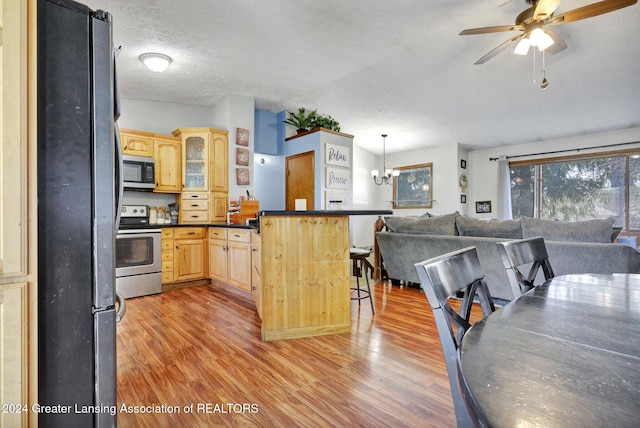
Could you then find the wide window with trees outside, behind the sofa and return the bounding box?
[510,152,640,231]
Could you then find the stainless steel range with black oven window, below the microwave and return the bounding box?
[115,205,162,299]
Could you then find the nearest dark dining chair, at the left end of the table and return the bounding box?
[414,247,495,427]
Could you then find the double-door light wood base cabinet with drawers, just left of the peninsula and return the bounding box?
[209,227,252,292]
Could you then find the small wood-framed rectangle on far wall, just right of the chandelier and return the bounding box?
[393,163,433,208]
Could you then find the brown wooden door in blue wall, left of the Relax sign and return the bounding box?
[285,151,315,211]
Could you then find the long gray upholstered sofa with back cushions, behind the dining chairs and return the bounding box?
[376,213,640,300]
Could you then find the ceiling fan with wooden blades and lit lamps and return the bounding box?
[460,0,638,65]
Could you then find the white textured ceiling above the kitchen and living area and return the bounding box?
[80,0,640,153]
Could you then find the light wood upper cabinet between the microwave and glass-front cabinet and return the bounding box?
[153,136,182,193]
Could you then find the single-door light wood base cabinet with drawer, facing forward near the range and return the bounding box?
[173,227,207,282]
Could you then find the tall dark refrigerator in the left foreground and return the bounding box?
[37,0,118,428]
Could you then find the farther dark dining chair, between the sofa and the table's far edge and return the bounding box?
[496,236,555,298]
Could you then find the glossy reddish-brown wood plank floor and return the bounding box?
[117,283,479,428]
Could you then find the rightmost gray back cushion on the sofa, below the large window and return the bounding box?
[521,217,613,243]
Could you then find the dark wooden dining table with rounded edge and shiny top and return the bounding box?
[458,274,640,428]
